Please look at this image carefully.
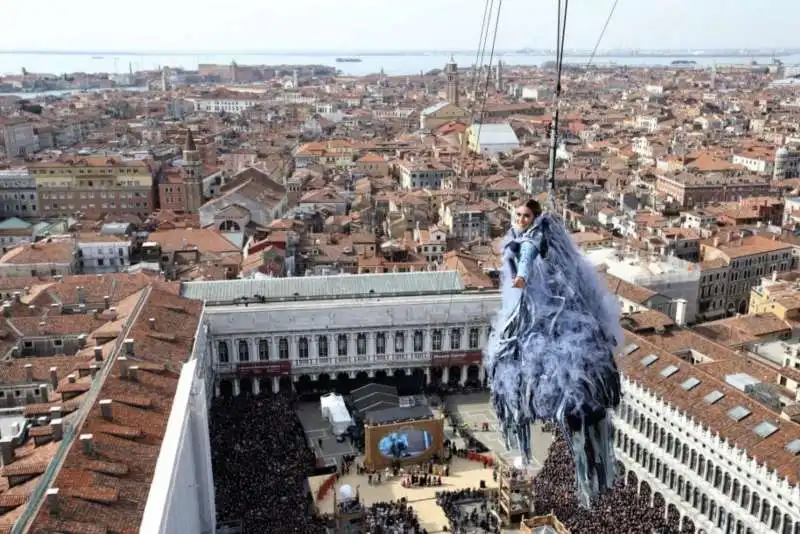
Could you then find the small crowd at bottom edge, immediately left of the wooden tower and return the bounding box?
[436,489,500,534]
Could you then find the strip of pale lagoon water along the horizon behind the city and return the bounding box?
[0,52,800,76]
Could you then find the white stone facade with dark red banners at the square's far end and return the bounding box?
[199,293,499,394]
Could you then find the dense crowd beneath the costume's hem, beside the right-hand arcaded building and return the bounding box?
[533,434,691,534]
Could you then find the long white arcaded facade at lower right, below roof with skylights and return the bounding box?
[614,379,800,534]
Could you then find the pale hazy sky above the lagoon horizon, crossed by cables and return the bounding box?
[0,0,800,51]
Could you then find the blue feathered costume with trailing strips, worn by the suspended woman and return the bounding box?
[484,213,623,506]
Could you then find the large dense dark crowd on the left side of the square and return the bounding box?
[209,395,325,534]
